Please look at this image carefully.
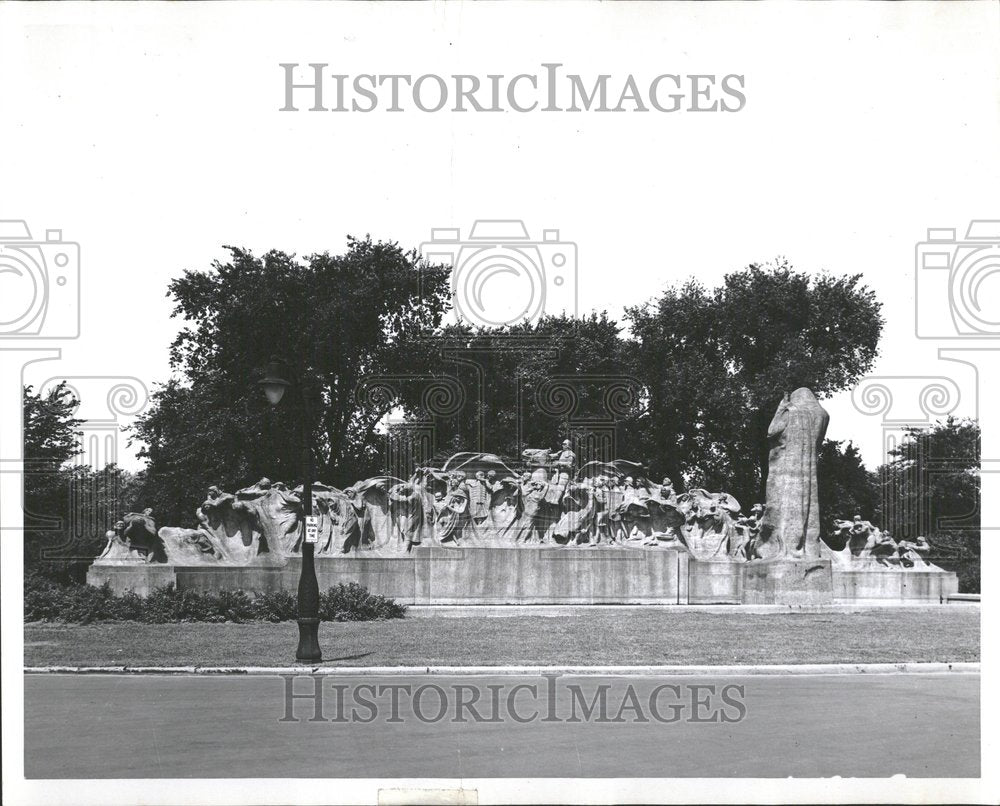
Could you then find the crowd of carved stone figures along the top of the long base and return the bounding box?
[98,441,933,569]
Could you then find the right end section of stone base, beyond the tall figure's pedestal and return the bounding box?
[833,568,958,605]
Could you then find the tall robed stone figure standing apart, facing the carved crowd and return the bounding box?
[756,387,830,559]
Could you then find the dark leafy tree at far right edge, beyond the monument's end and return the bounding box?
[876,417,981,593]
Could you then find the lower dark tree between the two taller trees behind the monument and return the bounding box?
[386,313,642,474]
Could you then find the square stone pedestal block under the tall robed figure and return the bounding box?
[740,559,833,607]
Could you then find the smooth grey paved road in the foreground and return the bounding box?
[25,673,980,778]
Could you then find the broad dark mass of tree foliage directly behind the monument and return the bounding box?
[121,243,883,523]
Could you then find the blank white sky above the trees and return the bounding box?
[0,3,1000,469]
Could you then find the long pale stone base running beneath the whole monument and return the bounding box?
[87,546,958,606]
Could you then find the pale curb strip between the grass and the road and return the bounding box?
[24,662,980,677]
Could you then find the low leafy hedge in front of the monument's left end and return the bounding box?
[24,574,406,624]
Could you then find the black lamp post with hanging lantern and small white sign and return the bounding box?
[257,358,323,663]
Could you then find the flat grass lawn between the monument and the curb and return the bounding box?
[24,605,979,666]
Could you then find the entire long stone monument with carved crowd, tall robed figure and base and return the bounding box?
[88,388,957,605]
